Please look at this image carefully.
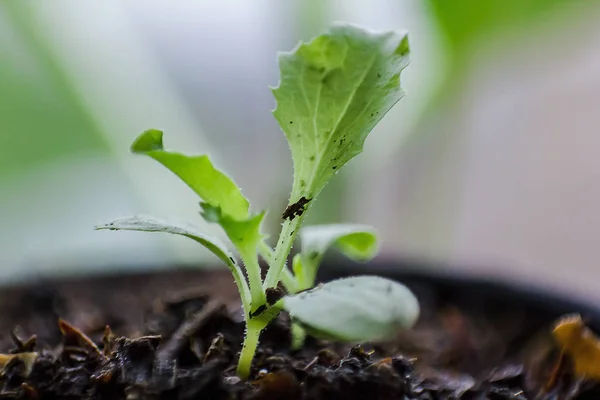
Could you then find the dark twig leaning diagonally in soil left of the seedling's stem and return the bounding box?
[156,300,224,363]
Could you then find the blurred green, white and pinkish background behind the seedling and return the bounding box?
[0,0,600,299]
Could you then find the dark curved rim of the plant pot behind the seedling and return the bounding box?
[0,260,600,346]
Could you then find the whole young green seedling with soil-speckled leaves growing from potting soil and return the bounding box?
[97,25,419,379]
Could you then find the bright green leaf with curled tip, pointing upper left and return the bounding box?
[131,129,249,220]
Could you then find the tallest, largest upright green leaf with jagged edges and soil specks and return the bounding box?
[273,25,409,204]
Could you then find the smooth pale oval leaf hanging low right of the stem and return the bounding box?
[283,276,419,343]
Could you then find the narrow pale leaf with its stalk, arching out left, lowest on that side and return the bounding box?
[95,215,250,309]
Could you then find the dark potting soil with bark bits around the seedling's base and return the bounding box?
[0,262,600,400]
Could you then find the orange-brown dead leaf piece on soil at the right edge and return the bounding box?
[552,314,600,380]
